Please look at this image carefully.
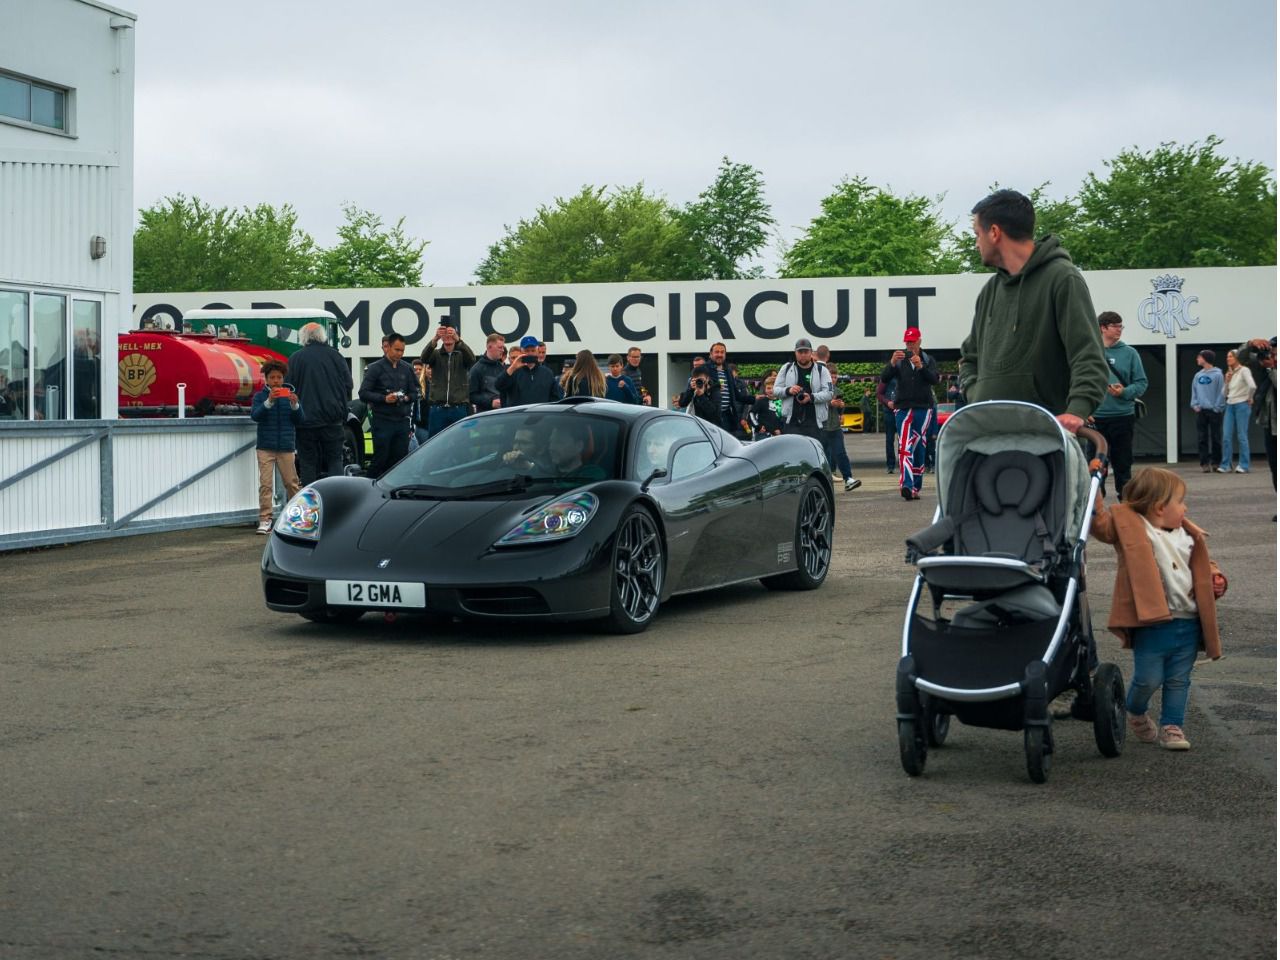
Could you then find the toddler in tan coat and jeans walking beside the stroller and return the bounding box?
[1092,467,1226,750]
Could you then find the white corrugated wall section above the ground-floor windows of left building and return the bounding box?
[0,161,119,289]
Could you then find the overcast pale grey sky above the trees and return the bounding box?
[124,0,1276,285]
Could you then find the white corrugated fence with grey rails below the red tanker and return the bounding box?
[0,417,257,550]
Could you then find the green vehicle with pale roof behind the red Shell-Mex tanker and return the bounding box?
[182,307,374,468]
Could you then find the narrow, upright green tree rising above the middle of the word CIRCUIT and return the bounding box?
[671,156,774,280]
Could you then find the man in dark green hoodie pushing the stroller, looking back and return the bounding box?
[960,189,1110,434]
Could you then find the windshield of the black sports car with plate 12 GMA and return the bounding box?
[379,408,620,499]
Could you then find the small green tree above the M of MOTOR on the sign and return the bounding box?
[314,204,428,288]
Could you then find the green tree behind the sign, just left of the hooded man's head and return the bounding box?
[782,177,961,278]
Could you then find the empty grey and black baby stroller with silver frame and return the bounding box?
[897,401,1125,783]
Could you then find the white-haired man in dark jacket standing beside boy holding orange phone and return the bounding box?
[285,324,352,485]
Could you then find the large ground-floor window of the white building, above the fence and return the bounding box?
[0,289,102,420]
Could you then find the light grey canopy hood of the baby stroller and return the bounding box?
[937,401,1089,543]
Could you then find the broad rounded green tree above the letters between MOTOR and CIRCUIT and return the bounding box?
[476,183,686,284]
